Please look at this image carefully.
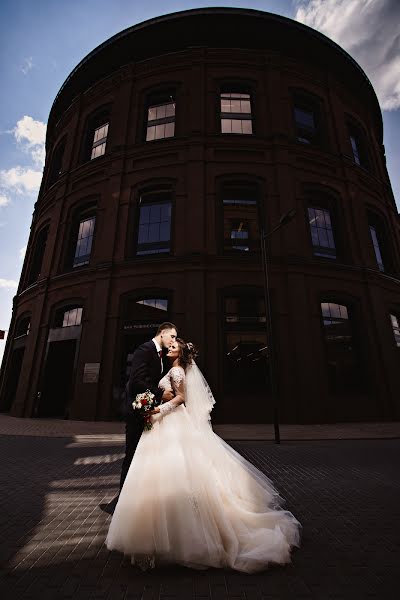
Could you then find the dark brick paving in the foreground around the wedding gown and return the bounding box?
[0,425,400,600]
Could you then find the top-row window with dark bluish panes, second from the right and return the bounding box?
[293,93,326,146]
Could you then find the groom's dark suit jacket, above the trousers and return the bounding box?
[124,340,165,419]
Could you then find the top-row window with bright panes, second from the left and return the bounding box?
[145,91,175,142]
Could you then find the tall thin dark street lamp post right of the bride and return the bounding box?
[260,208,296,444]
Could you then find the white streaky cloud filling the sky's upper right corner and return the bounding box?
[294,0,400,110]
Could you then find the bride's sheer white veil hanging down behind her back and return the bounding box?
[185,361,215,429]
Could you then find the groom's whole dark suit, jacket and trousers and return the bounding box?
[120,340,164,489]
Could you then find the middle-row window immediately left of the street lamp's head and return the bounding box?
[222,183,260,253]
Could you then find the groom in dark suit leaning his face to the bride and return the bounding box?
[120,323,177,490]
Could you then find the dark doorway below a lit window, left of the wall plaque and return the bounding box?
[37,340,77,418]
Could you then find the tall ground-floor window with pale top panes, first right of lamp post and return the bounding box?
[321,302,363,394]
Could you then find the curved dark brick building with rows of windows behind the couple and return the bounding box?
[0,9,400,422]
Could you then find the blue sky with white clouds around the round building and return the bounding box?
[0,0,400,362]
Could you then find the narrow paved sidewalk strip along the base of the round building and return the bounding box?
[0,414,400,441]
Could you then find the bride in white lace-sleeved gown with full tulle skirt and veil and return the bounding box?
[106,339,301,573]
